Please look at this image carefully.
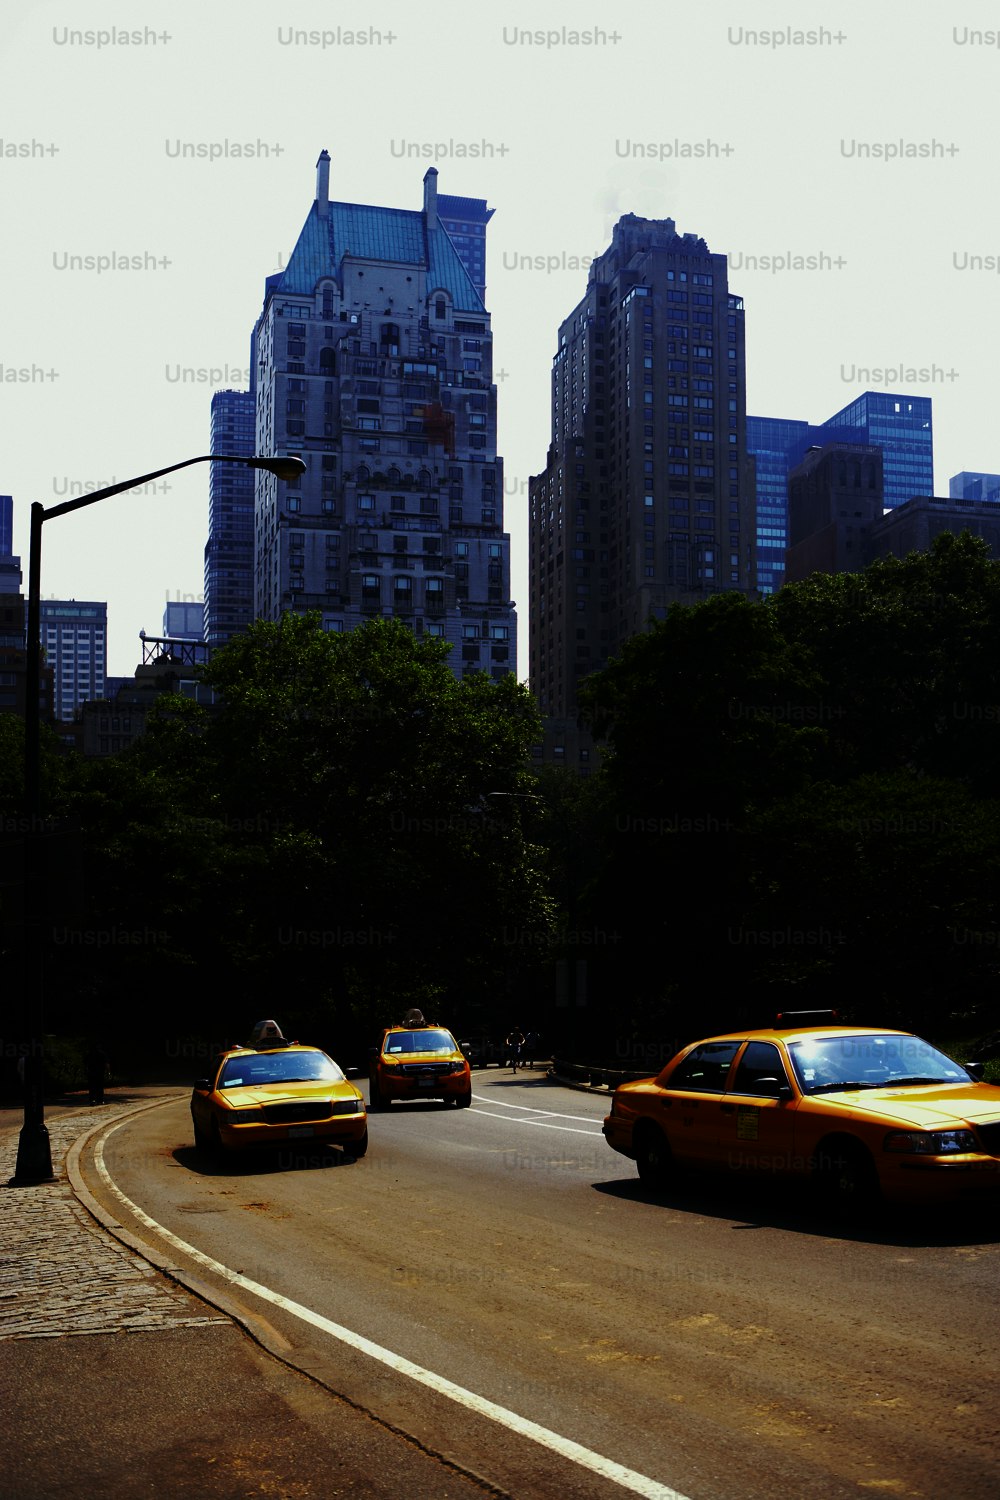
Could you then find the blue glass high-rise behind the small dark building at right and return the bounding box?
[747,390,934,594]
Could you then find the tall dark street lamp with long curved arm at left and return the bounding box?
[10,453,306,1187]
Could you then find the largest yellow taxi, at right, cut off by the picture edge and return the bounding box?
[604,1011,1000,1208]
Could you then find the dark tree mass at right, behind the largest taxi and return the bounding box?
[575,534,1000,1056]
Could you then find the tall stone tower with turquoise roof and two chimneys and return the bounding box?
[253,152,516,677]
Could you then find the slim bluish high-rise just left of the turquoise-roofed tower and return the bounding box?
[202,384,255,647]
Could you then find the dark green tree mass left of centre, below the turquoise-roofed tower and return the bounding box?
[7,615,549,1050]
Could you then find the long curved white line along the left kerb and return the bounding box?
[94,1116,687,1500]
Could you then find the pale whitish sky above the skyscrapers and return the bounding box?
[0,0,1000,677]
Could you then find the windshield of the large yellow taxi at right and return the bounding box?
[787,1034,972,1094]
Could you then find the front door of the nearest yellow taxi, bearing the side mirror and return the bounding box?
[718,1041,796,1172]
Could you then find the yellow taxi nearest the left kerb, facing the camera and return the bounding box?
[190,1020,367,1157]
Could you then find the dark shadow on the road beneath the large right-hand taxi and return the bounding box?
[591,1176,1000,1250]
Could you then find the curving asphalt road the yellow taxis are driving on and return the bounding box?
[85,1070,1000,1500]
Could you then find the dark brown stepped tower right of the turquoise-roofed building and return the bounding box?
[529,215,754,719]
